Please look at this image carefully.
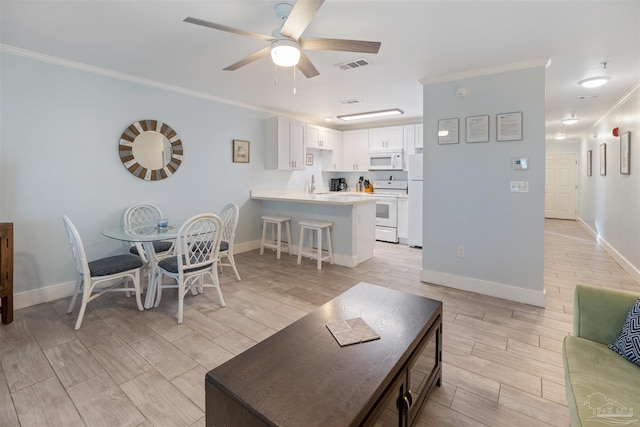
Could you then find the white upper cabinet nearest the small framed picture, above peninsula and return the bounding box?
[265,117,306,170]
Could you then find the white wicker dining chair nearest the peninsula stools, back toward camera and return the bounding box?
[155,213,225,324]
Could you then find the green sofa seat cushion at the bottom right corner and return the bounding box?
[562,336,640,426]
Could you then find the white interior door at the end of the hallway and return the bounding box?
[544,153,578,219]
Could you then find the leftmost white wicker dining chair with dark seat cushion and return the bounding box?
[62,215,144,330]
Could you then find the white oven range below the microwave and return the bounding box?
[373,180,408,243]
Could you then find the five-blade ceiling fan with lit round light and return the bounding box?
[184,0,380,79]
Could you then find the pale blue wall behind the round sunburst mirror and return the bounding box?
[0,53,318,293]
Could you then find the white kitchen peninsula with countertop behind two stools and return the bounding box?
[251,190,376,267]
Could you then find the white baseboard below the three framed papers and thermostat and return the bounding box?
[420,269,546,307]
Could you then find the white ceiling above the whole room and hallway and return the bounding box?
[0,0,640,142]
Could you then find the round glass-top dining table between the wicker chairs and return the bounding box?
[101,221,182,308]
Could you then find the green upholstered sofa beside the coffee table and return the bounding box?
[562,286,640,427]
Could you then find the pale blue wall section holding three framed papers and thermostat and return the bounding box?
[422,66,545,302]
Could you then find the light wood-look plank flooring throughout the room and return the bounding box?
[0,220,640,427]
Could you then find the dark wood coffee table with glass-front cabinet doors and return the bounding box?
[205,283,442,427]
